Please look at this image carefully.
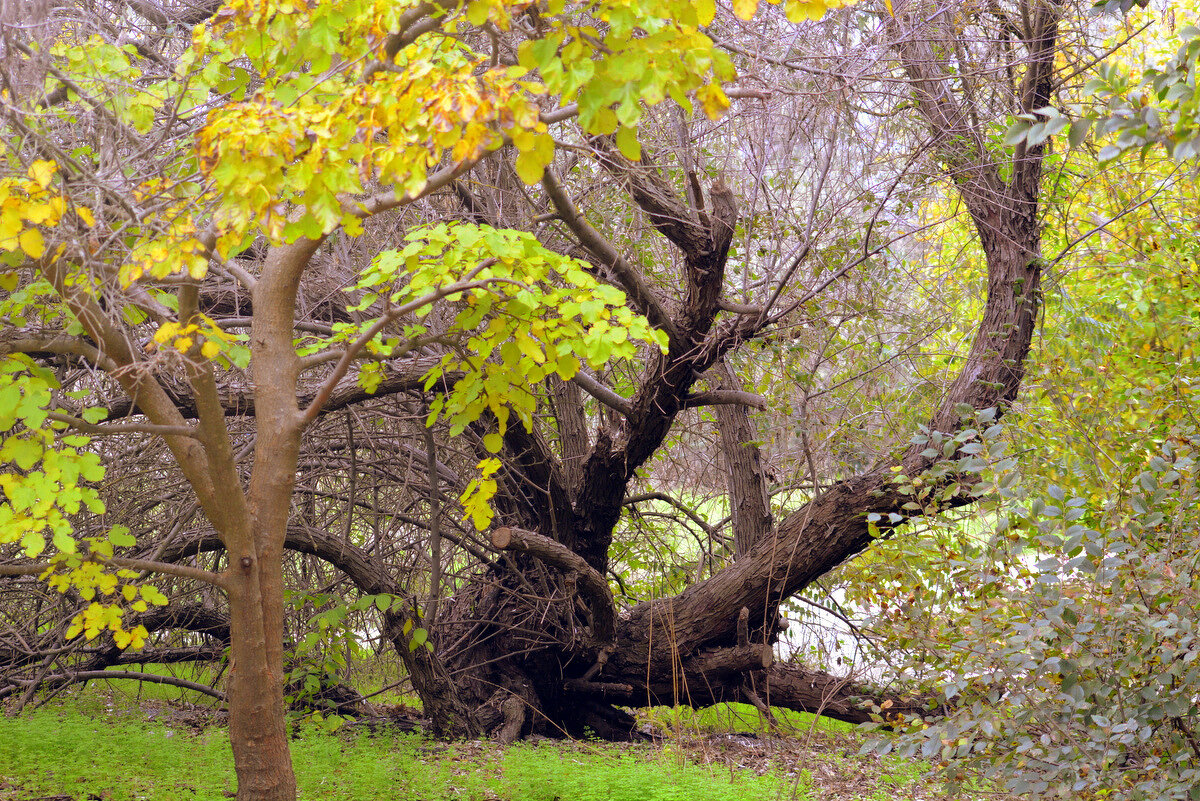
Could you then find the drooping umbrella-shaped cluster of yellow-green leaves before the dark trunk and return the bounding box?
[345,223,667,530]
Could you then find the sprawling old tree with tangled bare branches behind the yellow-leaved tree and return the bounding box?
[0,0,1108,757]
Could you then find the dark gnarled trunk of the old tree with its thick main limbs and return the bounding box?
[410,2,1060,736]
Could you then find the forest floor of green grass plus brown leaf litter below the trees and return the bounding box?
[0,689,1003,801]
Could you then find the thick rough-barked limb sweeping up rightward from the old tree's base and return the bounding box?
[604,0,1052,695]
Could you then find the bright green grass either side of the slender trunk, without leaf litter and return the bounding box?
[0,697,808,801]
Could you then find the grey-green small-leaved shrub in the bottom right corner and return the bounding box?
[868,445,1200,800]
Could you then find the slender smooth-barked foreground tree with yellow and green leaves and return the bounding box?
[5,2,720,799]
